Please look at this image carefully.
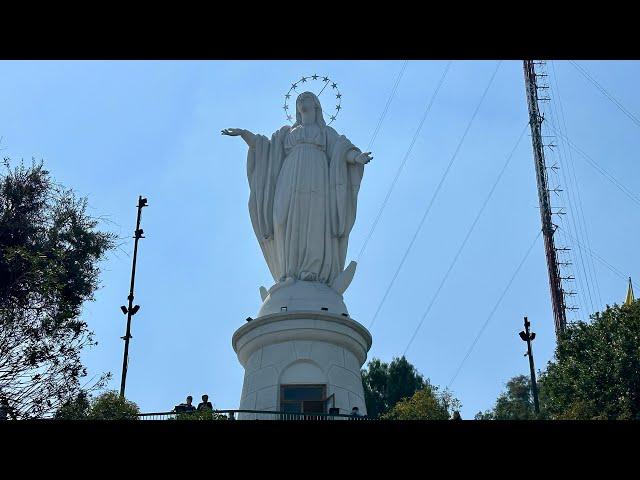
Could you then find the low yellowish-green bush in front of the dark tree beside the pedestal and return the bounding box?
[381,382,461,420]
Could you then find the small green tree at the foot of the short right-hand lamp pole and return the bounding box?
[475,375,540,420]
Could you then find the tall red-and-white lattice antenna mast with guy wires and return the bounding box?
[524,60,567,338]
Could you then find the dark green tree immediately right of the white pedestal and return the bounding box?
[362,356,427,418]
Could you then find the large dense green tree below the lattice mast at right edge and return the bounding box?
[541,301,640,420]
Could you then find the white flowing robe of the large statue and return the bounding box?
[247,126,364,284]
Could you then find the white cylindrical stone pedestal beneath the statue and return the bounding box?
[232,311,371,419]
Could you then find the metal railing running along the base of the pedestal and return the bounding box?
[138,410,372,421]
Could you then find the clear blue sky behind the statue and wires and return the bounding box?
[0,61,640,418]
